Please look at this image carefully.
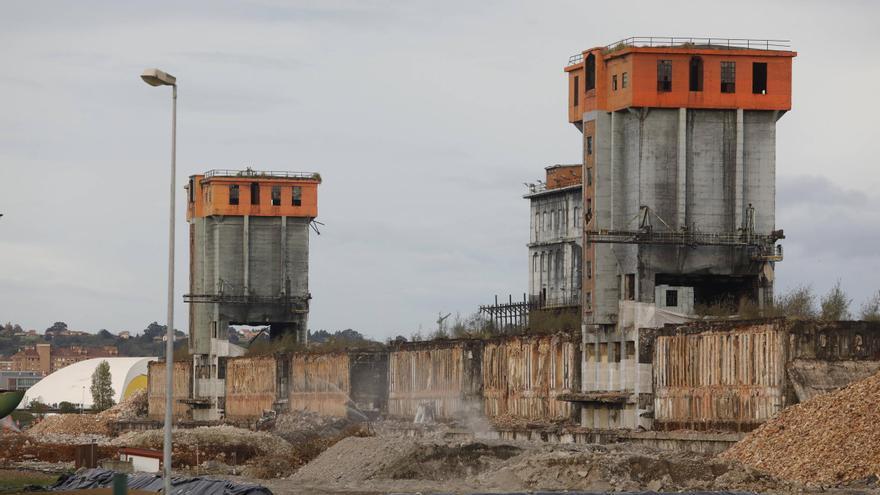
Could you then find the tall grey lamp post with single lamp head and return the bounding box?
[141,69,177,494]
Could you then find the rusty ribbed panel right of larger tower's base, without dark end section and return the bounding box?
[654,322,787,431]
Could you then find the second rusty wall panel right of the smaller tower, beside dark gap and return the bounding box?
[289,354,351,417]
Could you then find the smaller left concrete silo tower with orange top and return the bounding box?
[185,169,321,420]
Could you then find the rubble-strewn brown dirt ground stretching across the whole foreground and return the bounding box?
[10,406,880,495]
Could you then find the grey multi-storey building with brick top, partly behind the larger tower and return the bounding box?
[523,164,583,307]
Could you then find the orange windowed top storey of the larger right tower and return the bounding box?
[565,37,797,123]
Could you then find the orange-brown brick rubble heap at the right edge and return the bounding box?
[722,374,880,484]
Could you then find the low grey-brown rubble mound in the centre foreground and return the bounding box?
[289,437,801,493]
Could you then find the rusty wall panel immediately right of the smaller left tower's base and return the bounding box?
[226,356,276,419]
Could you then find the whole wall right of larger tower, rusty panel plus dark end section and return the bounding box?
[653,319,880,431]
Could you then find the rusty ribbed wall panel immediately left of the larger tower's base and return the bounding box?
[482,334,580,420]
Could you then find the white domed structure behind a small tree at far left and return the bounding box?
[19,357,157,409]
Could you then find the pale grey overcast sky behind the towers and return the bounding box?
[0,0,880,338]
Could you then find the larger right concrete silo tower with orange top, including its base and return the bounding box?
[565,38,796,427]
